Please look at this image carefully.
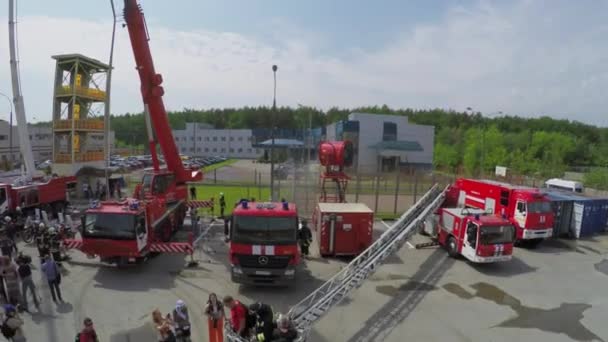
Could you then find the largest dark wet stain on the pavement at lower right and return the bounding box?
[443,283,604,341]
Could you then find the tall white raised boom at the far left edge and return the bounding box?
[8,0,36,182]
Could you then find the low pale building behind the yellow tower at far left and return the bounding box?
[0,120,114,168]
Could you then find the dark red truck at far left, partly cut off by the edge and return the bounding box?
[0,176,76,214]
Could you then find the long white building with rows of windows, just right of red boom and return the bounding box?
[173,122,264,159]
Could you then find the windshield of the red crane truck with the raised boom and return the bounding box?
[82,214,136,240]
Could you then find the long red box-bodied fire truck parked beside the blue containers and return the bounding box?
[448,178,554,245]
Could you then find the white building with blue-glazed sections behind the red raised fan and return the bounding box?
[326,113,435,173]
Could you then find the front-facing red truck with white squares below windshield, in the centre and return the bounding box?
[229,201,300,285]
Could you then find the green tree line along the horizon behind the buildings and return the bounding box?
[111,106,608,183]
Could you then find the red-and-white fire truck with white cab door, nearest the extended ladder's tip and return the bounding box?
[435,208,515,263]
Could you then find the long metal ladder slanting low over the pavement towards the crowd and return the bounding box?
[225,185,447,342]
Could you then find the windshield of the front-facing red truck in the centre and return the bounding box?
[232,216,297,245]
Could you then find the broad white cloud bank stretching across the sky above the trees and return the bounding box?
[0,1,608,126]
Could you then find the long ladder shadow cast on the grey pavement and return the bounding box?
[348,249,454,342]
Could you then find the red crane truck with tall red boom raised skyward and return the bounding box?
[65,0,202,265]
